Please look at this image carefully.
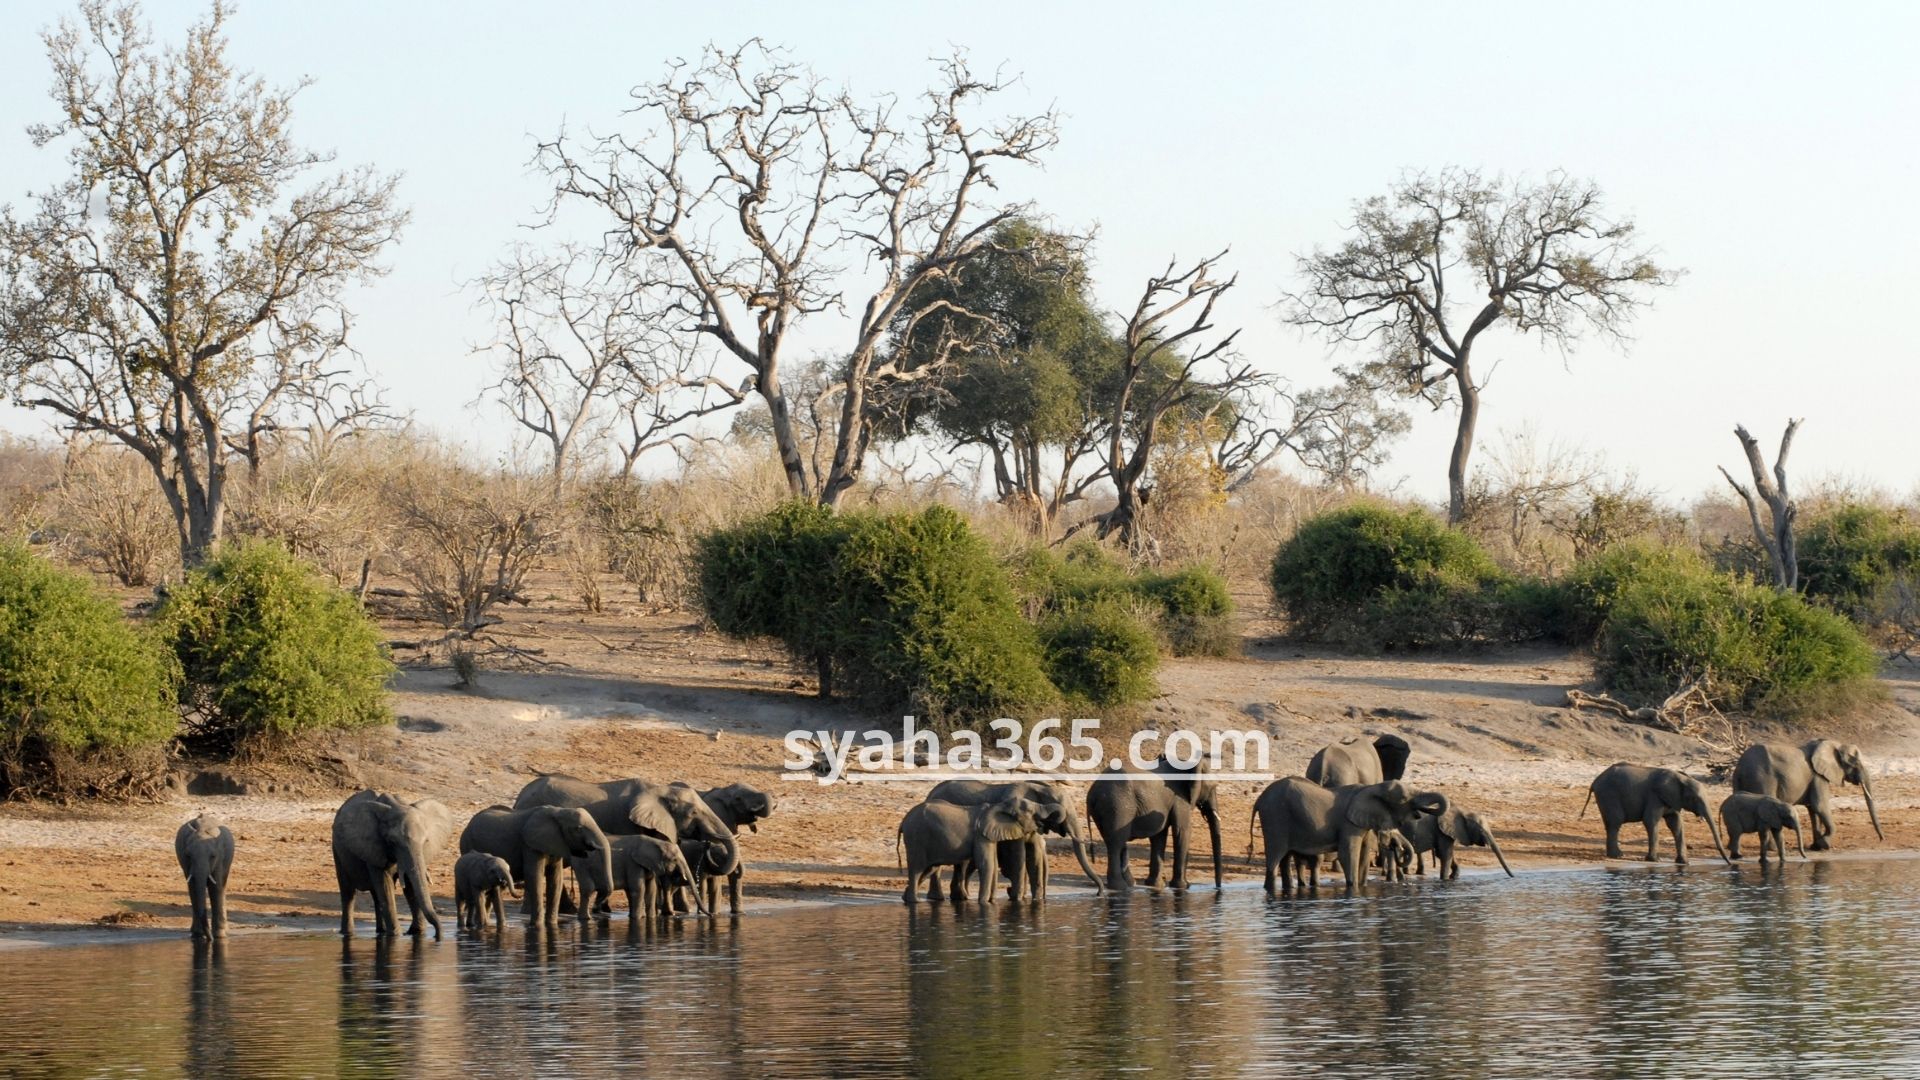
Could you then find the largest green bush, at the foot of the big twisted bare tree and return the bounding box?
[695,503,1056,724]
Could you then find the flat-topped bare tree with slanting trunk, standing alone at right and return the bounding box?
[1284,169,1674,525]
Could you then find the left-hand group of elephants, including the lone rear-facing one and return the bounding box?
[175,774,774,938]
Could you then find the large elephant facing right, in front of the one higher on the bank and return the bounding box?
[1248,776,1448,896]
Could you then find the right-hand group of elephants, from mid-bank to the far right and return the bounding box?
[897,734,1884,903]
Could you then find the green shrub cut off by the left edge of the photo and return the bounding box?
[0,544,179,794]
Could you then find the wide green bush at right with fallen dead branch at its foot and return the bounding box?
[1596,545,1880,713]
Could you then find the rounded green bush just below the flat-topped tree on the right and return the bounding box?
[1271,505,1505,648]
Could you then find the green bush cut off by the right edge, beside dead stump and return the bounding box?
[1799,503,1920,621]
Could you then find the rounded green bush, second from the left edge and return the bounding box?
[154,540,394,748]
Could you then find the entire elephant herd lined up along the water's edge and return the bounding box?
[175,734,1885,938]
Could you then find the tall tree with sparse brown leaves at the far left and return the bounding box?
[0,0,405,565]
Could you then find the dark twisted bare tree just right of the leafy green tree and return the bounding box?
[1068,252,1269,548]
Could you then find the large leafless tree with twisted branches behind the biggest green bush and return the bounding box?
[538,40,1056,505]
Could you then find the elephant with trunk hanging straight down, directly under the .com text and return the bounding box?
[1087,757,1223,892]
